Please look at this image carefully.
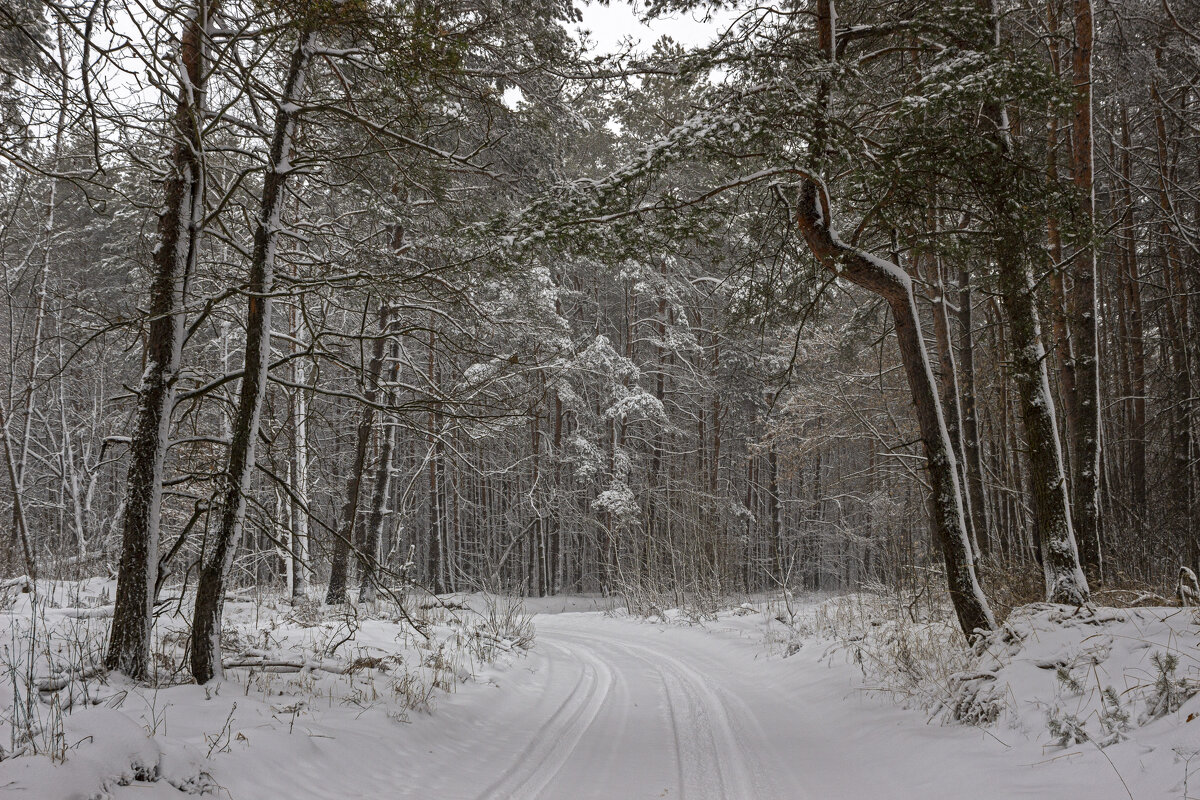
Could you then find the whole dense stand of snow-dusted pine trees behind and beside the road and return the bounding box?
[0,0,1200,682]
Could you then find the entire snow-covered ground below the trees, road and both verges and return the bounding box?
[0,582,1200,800]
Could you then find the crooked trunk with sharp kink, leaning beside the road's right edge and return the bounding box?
[796,0,996,638]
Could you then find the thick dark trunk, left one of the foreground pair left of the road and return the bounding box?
[104,0,217,680]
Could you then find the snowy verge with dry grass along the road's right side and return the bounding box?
[755,594,1200,800]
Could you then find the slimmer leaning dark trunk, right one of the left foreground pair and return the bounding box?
[192,31,316,684]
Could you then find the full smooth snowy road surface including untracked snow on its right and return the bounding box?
[403,614,1128,800]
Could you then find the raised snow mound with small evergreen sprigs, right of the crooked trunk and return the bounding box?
[935,603,1200,796]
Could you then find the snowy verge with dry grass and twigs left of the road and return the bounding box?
[0,579,534,800]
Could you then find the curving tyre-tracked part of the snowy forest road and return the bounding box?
[412,614,806,800]
